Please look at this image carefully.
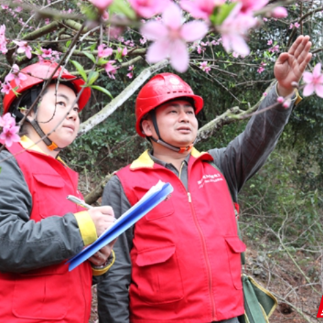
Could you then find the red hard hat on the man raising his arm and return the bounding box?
[136,73,203,137]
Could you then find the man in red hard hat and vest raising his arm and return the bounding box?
[98,36,311,323]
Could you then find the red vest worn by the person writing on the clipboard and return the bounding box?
[0,143,92,323]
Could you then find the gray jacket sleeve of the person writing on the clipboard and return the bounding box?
[0,150,84,272]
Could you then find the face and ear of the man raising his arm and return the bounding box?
[142,99,198,147]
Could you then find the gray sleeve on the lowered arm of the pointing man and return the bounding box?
[97,176,133,323]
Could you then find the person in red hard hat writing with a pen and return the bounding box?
[0,61,114,323]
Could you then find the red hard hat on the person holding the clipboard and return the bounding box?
[3,60,91,114]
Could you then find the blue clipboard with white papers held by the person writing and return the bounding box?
[67,181,173,271]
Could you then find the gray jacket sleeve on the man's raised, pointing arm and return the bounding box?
[209,88,292,201]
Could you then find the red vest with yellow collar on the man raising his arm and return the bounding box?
[117,149,246,323]
